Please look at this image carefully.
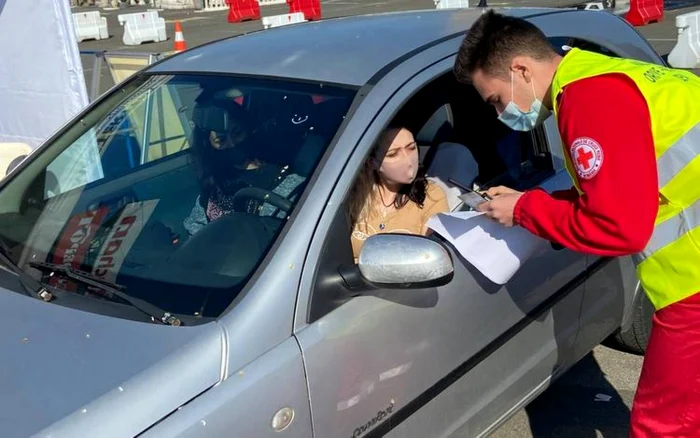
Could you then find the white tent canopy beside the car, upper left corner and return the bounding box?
[0,0,88,150]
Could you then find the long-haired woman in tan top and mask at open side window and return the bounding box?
[348,125,449,263]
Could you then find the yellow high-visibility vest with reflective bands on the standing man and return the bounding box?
[552,48,700,310]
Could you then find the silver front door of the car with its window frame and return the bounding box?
[296,54,585,438]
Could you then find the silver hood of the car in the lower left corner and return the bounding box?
[0,288,223,437]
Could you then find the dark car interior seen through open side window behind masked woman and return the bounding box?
[348,73,553,218]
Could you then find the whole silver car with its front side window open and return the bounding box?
[0,9,663,438]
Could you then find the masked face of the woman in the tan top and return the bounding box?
[379,128,418,184]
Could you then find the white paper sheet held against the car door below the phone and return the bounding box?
[428,211,549,284]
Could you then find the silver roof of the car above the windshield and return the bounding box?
[148,8,561,86]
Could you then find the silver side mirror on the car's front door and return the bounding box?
[346,233,454,289]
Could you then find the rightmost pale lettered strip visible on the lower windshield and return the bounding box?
[92,199,158,282]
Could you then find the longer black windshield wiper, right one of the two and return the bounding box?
[29,262,182,326]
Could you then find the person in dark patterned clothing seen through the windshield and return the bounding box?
[184,101,304,235]
